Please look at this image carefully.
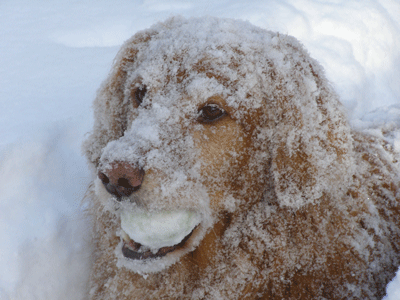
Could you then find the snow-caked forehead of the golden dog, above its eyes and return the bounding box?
[123,19,282,109]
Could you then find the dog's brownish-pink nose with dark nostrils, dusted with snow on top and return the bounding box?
[98,162,144,201]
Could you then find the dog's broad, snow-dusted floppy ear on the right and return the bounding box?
[265,37,354,208]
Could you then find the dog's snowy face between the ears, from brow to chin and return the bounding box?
[90,45,265,272]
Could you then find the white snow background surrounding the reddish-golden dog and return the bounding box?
[0,0,400,300]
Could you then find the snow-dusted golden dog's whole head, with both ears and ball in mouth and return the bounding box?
[84,18,352,272]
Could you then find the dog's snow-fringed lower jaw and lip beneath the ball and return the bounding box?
[116,223,208,274]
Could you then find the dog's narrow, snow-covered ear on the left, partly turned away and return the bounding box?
[82,30,155,165]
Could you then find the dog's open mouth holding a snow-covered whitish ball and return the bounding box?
[121,210,200,260]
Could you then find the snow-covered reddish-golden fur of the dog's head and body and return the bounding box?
[83,17,400,299]
